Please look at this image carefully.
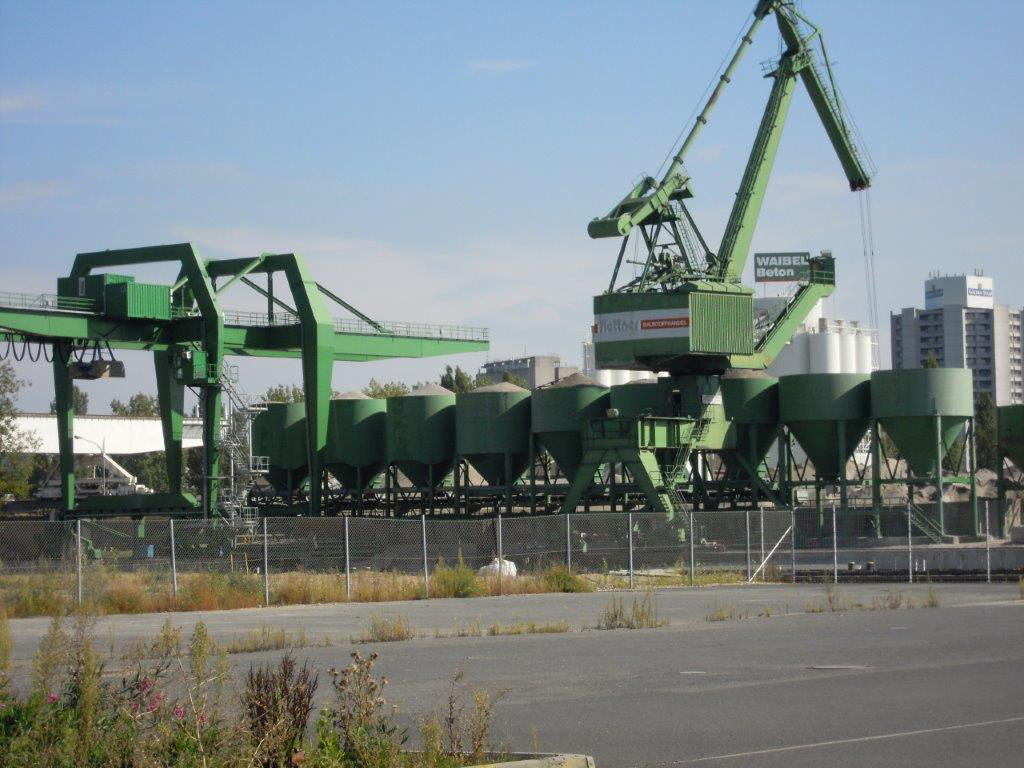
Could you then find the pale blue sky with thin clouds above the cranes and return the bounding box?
[0,0,1024,411]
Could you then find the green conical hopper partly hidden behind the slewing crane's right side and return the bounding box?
[721,369,778,475]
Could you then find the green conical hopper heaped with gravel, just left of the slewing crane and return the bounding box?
[530,374,609,482]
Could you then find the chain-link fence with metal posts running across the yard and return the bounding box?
[0,506,1024,605]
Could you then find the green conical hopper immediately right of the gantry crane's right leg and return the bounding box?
[324,392,387,490]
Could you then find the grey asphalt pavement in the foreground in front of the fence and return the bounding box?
[4,584,1024,768]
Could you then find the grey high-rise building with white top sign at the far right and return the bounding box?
[890,272,1024,406]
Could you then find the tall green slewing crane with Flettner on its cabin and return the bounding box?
[564,0,871,515]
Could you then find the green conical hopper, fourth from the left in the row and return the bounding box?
[455,383,529,485]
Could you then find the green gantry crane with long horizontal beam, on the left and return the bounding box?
[0,243,488,516]
